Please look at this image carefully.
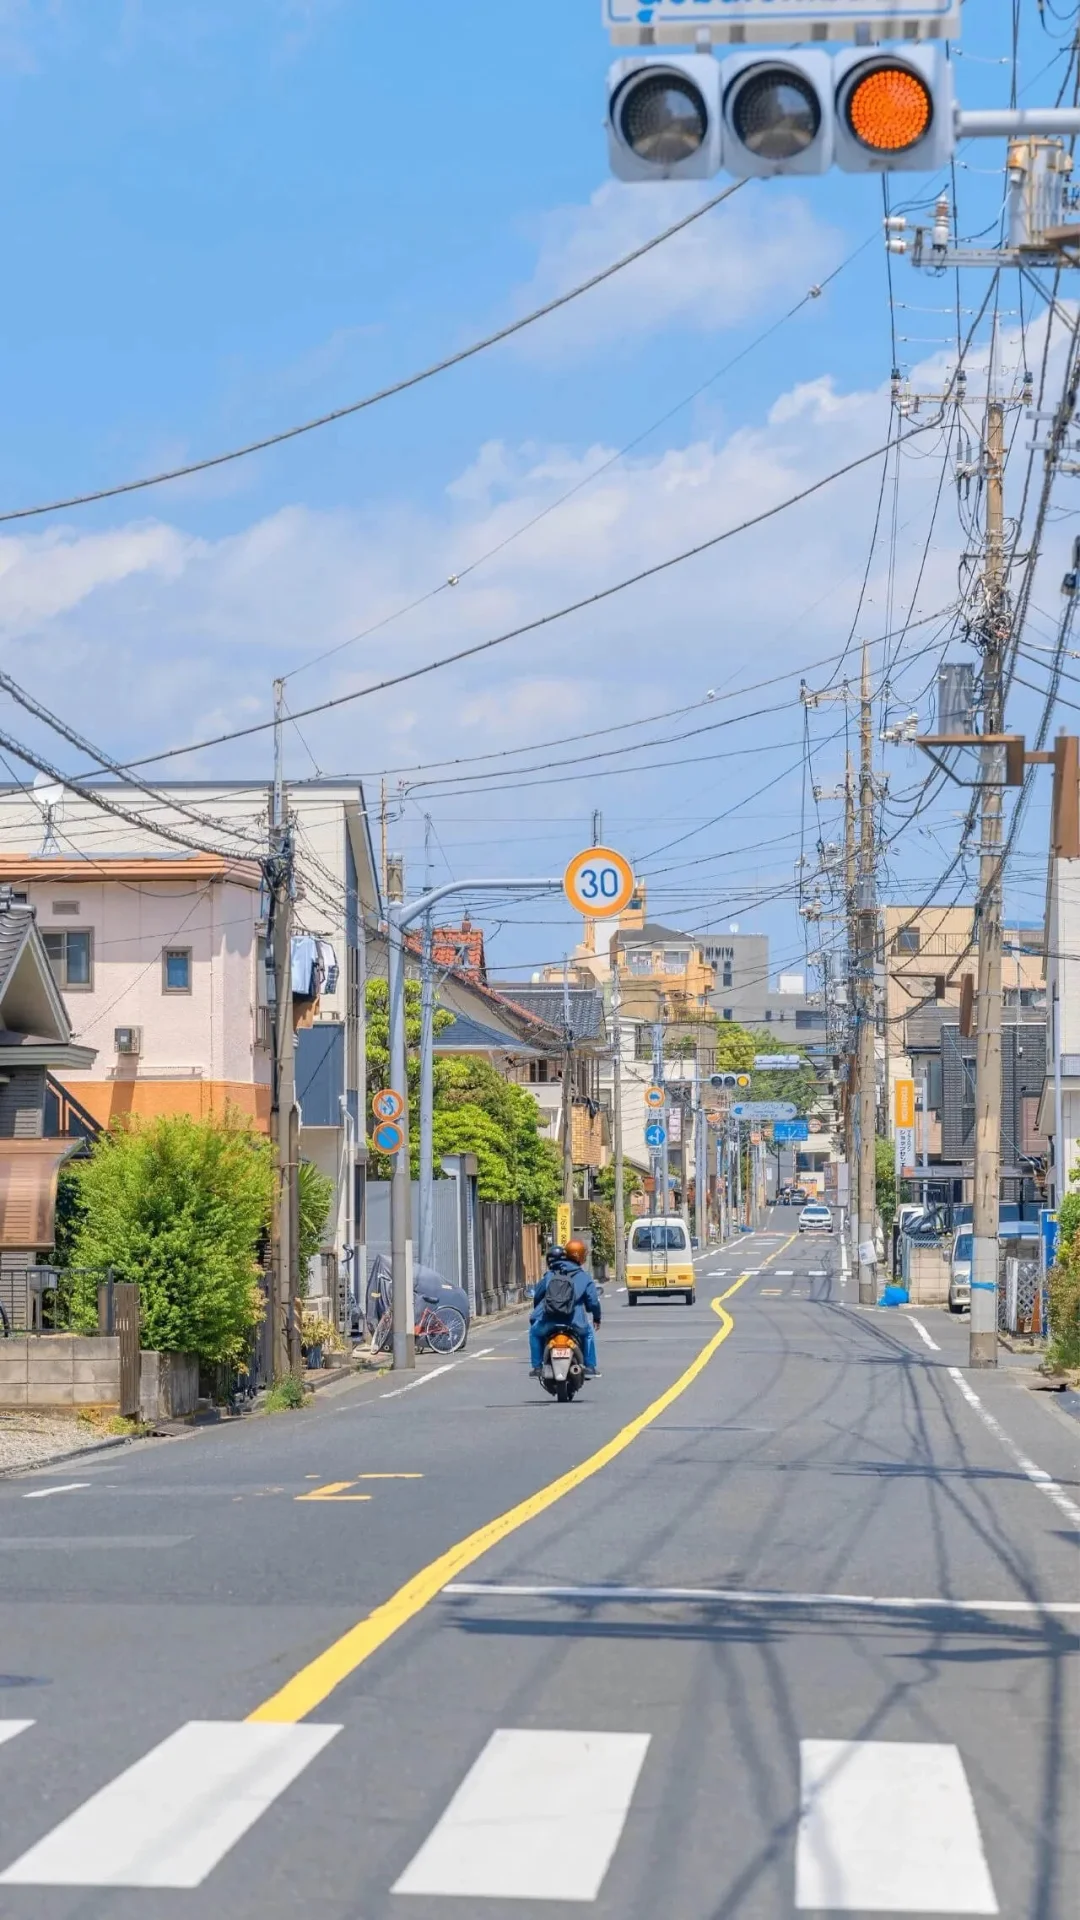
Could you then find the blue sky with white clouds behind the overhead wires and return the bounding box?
[0,0,1072,968]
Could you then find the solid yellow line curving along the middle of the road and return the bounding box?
[248,1274,753,1726]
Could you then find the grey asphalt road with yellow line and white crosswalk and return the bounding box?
[0,1212,1080,1920]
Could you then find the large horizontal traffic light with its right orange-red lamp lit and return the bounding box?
[607,44,955,180]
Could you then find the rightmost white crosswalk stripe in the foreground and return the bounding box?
[796,1740,997,1914]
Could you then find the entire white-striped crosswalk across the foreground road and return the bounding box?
[0,1720,997,1916]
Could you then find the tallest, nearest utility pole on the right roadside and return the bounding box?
[969,374,1009,1367]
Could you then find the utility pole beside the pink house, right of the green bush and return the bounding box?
[263,680,292,1380]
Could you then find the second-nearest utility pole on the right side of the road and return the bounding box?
[857,647,878,1308]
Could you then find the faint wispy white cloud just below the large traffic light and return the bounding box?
[515,180,842,359]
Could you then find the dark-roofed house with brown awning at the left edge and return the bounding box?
[0,887,94,1282]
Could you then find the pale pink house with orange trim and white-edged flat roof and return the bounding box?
[0,780,380,1320]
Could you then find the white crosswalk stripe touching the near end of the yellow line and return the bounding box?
[0,1720,340,1887]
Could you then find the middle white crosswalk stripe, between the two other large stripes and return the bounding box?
[392,1728,650,1901]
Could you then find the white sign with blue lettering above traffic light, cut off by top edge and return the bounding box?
[601,0,961,46]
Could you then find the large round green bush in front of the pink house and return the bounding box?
[71,1116,273,1361]
